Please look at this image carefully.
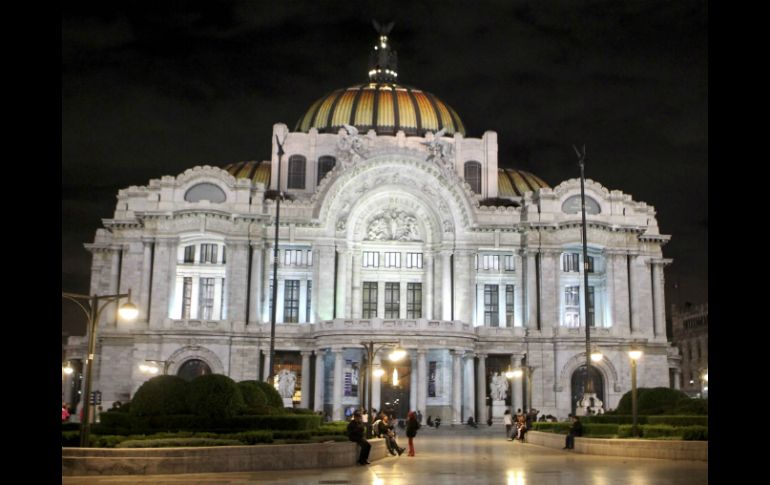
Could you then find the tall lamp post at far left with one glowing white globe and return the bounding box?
[61,290,139,447]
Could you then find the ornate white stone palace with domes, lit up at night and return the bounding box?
[66,29,680,424]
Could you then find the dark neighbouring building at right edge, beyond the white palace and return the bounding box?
[671,303,709,397]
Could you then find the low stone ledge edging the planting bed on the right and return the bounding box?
[527,431,708,462]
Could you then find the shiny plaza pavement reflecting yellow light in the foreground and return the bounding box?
[62,425,708,485]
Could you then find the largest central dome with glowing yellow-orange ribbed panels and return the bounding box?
[294,82,465,136]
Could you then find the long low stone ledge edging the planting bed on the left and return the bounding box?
[62,439,390,476]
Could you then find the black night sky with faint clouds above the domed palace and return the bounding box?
[62,0,708,334]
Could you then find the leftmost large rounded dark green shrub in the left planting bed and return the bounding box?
[130,376,190,416]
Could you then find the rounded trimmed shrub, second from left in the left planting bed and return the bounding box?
[188,374,245,418]
